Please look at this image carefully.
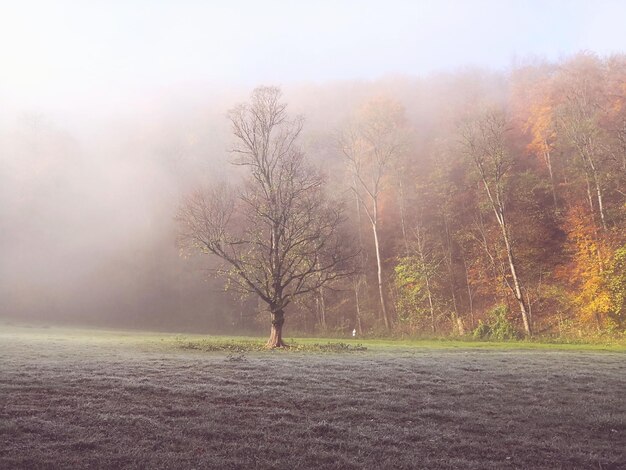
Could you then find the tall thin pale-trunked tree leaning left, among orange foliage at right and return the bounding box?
[461,110,532,336]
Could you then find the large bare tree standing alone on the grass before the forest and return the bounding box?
[178,87,354,348]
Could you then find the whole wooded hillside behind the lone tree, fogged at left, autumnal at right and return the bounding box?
[0,52,626,339]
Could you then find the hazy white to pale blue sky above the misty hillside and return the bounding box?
[0,0,626,116]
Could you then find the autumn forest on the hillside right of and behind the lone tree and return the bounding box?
[172,54,626,340]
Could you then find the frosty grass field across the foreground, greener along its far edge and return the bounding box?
[0,326,626,469]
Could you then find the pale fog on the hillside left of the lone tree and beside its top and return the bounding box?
[0,78,494,331]
